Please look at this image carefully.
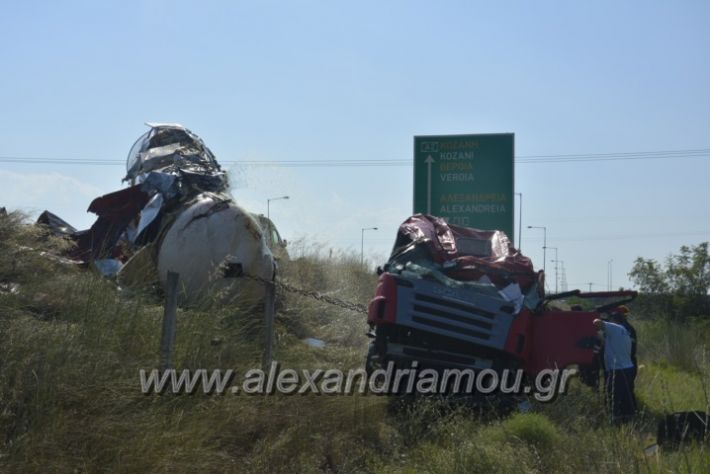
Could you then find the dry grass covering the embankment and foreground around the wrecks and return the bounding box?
[0,215,710,473]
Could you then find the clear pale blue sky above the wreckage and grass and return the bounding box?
[0,1,710,289]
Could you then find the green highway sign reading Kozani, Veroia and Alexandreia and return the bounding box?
[414,133,515,242]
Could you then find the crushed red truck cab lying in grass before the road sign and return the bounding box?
[367,214,636,392]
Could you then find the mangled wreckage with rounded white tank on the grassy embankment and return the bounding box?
[37,124,275,304]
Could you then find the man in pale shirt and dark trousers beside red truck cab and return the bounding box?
[594,319,636,423]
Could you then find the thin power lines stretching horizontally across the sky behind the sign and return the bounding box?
[0,148,710,168]
